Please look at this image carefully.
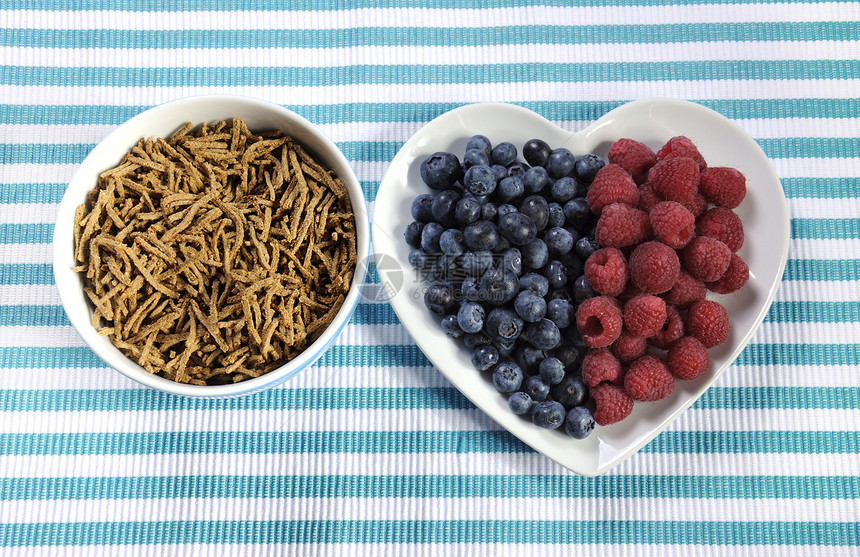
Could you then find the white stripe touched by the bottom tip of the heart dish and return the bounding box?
[0,451,860,478]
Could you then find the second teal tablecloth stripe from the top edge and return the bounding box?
[0,21,860,49]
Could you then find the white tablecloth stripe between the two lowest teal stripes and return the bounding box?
[0,490,857,524]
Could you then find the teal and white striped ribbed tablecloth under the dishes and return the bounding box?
[0,0,860,556]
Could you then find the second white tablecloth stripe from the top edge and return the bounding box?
[0,41,858,68]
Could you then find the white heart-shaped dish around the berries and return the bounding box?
[371,99,789,476]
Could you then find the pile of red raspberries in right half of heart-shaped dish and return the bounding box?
[576,136,749,425]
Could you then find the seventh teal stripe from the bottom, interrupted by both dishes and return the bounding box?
[15,259,860,284]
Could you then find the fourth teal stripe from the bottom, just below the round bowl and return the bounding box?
[0,387,860,412]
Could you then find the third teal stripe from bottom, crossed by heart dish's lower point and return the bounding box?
[0,430,860,455]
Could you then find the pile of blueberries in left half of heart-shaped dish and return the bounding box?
[405,135,605,439]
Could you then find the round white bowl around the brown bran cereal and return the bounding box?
[54,95,370,397]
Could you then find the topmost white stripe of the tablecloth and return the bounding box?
[0,2,856,30]
